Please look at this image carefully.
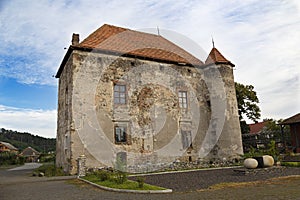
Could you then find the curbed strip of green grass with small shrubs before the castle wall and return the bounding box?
[82,174,165,190]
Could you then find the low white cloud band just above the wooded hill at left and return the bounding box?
[0,105,56,138]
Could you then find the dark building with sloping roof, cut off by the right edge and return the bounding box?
[280,113,300,153]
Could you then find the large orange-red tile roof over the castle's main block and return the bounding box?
[77,24,203,65]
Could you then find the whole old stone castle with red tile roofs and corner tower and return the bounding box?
[56,24,243,174]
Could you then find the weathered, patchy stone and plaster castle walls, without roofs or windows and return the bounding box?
[57,50,242,174]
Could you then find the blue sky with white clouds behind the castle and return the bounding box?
[0,0,300,138]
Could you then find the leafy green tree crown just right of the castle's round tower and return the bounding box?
[235,83,261,121]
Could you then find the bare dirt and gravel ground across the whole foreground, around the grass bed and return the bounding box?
[0,165,300,200]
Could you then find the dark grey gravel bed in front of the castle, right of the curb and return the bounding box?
[132,167,300,192]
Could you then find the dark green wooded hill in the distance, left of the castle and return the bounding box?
[0,128,56,153]
